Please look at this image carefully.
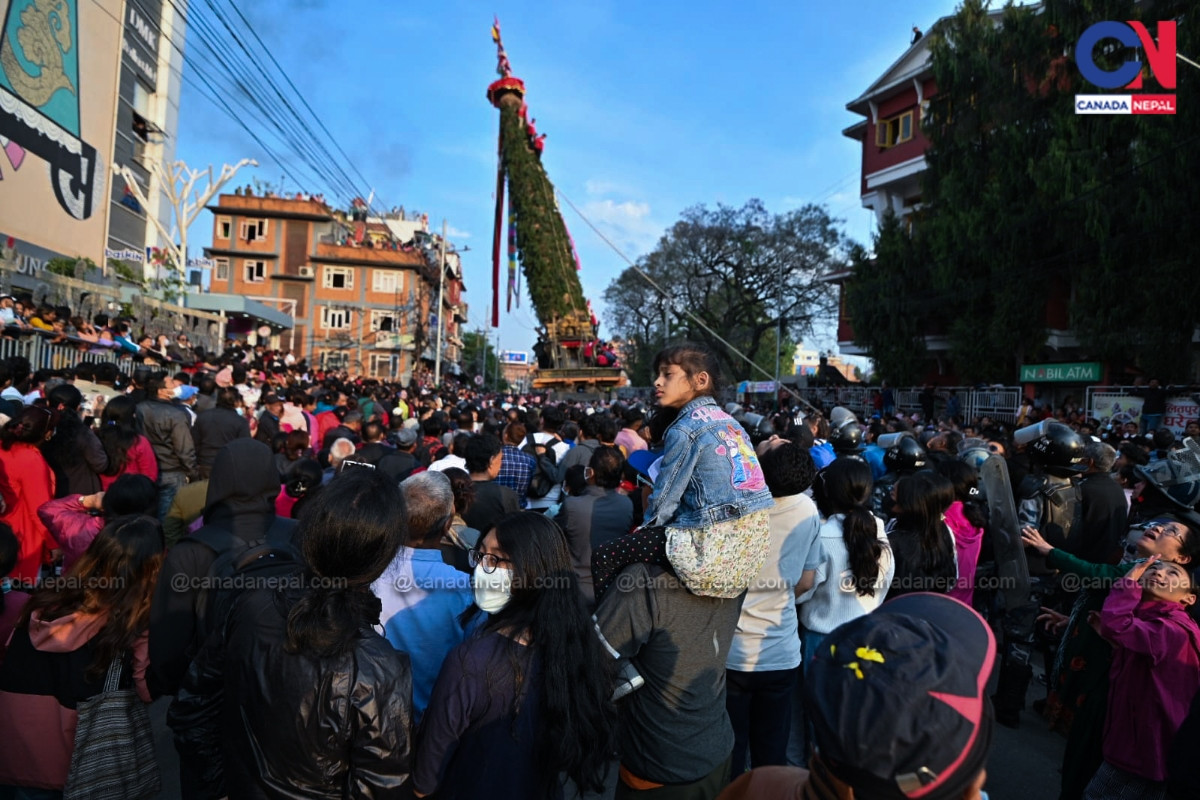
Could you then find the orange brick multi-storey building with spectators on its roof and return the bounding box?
[204,190,467,383]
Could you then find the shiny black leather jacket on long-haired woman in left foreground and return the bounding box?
[168,589,413,800]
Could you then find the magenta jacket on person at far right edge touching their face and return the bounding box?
[1100,578,1200,781]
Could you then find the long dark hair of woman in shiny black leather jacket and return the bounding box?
[286,469,408,657]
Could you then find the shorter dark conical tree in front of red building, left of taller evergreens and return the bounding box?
[845,211,934,385]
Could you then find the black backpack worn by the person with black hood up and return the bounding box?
[190,517,304,644]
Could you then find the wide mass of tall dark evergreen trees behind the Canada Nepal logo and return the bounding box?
[907,0,1200,379]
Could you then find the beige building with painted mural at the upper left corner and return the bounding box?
[0,0,184,289]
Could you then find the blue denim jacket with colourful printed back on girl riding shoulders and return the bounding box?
[646,397,774,528]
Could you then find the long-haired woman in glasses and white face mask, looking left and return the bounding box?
[413,512,616,800]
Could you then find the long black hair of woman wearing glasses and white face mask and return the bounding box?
[472,511,617,796]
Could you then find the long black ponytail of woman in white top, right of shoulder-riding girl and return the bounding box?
[812,458,883,597]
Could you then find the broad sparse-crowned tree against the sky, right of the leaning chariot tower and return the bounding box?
[605,200,845,385]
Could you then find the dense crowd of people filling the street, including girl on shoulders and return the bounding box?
[0,340,1200,800]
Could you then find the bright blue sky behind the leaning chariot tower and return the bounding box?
[176,0,955,362]
